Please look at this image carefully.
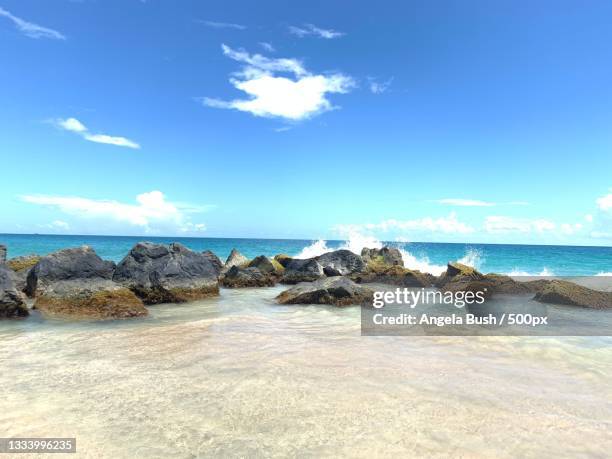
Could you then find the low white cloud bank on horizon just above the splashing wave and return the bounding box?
[334,212,474,234]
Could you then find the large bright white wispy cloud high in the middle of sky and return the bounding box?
[202,45,355,121]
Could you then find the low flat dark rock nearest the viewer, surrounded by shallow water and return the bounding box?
[276,277,374,306]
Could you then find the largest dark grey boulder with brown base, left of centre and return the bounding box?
[113,242,219,304]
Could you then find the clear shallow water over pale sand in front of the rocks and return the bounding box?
[0,287,612,458]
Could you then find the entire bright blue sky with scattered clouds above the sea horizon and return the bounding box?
[0,0,612,246]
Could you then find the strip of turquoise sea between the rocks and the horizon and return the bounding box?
[0,234,612,276]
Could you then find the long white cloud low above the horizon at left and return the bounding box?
[21,191,206,233]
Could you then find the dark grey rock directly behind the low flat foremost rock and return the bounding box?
[282,250,365,284]
